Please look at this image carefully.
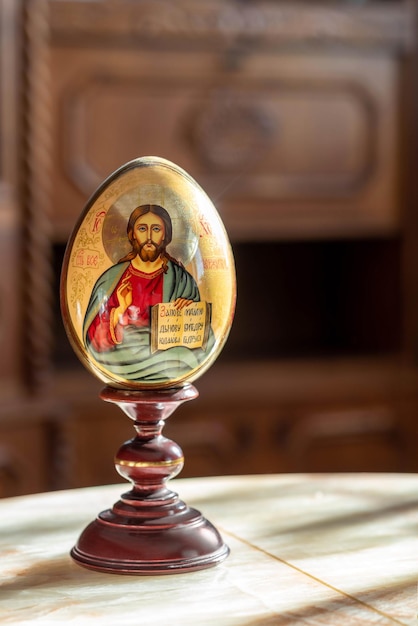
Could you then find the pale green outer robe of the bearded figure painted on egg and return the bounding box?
[83,261,214,384]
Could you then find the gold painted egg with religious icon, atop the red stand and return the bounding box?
[61,157,236,389]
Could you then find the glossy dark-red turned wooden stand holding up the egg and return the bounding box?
[71,384,229,574]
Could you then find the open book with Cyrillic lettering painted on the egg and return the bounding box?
[151,302,212,352]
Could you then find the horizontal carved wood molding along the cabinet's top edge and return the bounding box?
[49,0,415,48]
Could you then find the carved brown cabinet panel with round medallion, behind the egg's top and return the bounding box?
[51,47,398,238]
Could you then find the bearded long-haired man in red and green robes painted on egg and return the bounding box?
[84,204,214,383]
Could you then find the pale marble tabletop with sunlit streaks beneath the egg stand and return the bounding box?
[0,474,418,626]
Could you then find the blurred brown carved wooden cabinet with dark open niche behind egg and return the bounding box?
[0,0,418,498]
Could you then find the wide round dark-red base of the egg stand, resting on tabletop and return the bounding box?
[71,494,229,575]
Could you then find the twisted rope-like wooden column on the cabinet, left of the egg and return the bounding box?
[22,0,53,392]
